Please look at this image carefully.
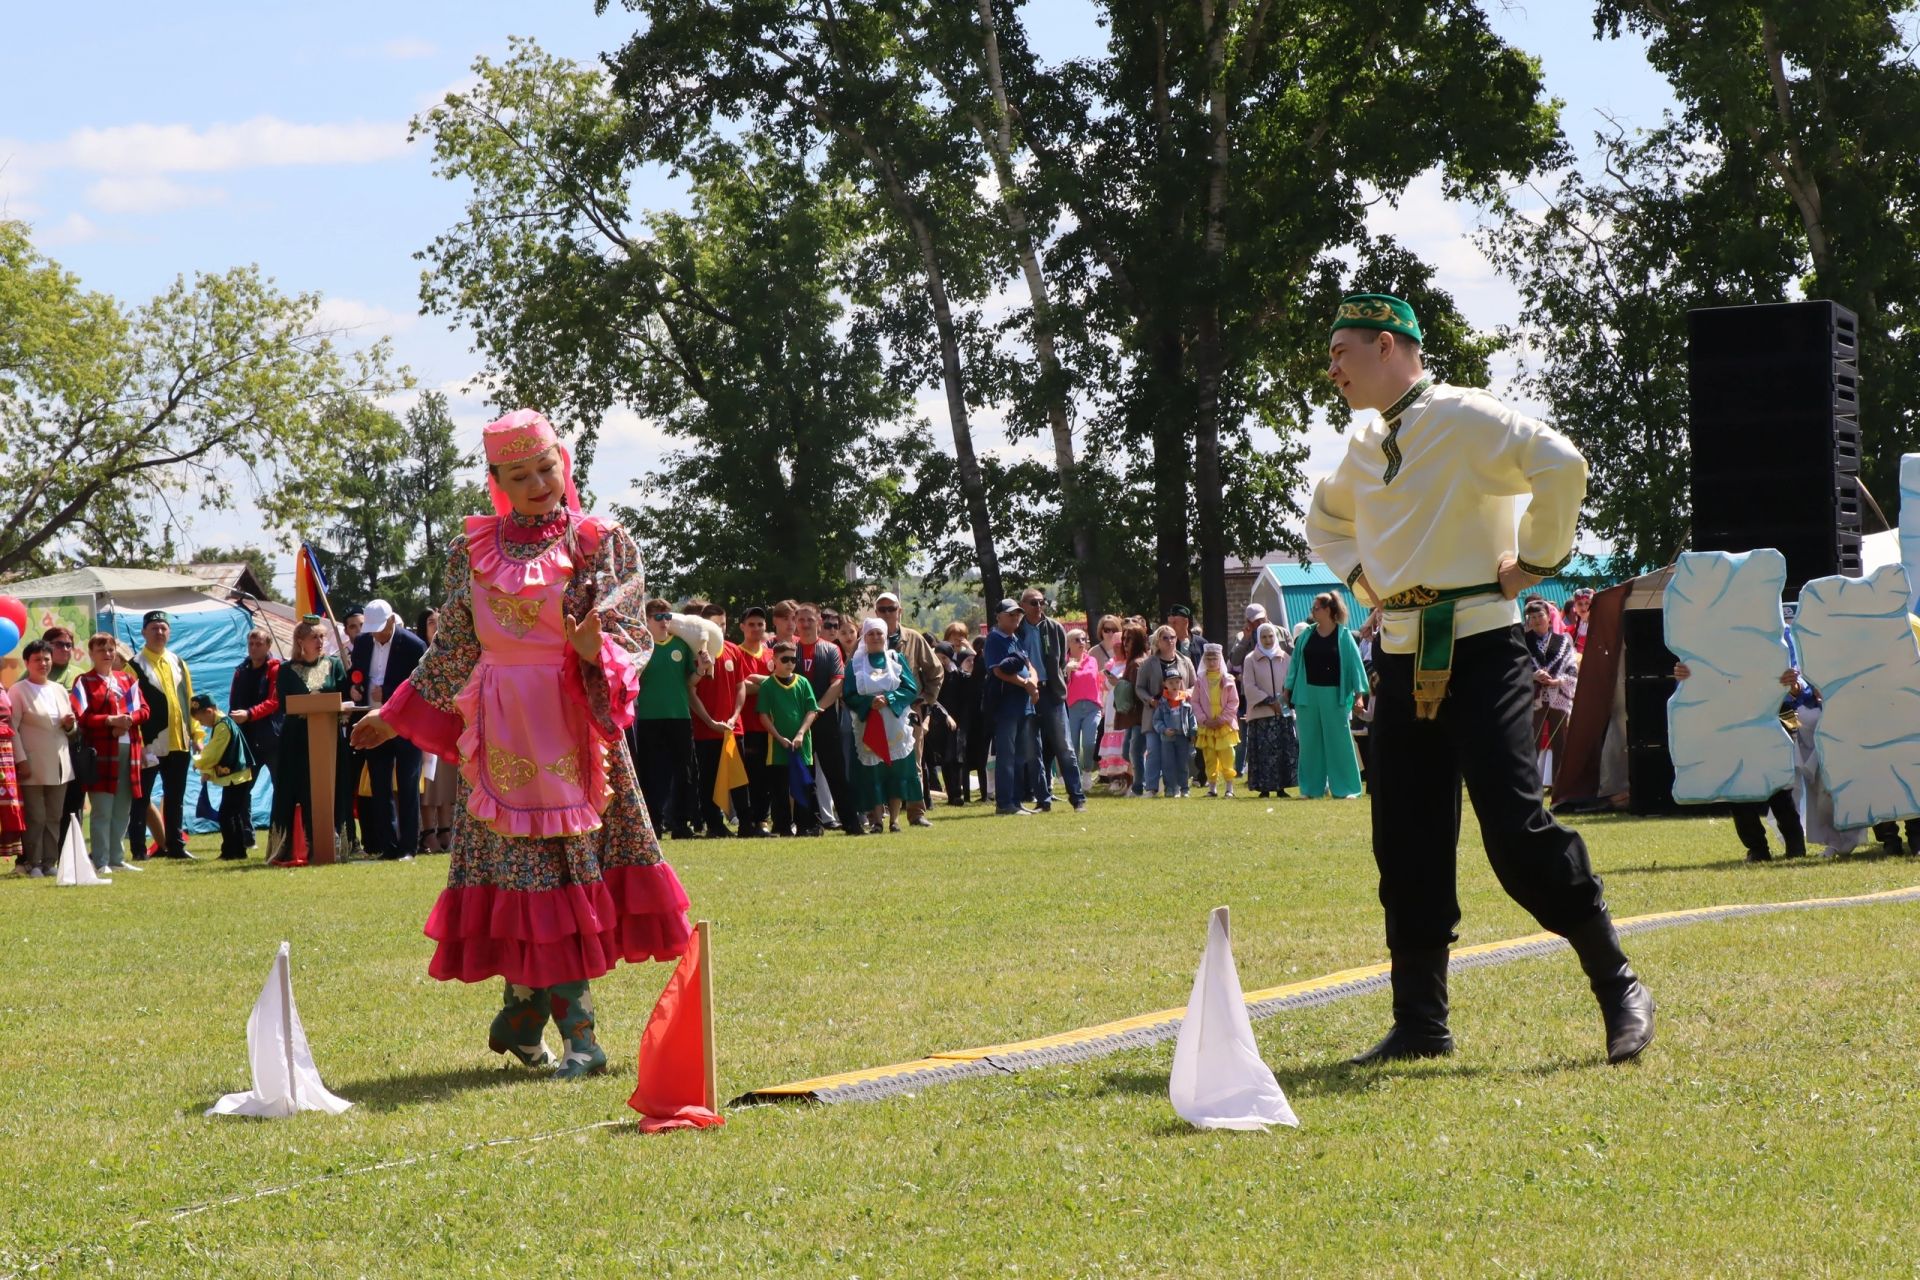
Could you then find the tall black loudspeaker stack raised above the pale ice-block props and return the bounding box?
[1697,301,1860,598]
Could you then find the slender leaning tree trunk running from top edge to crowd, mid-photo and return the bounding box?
[975,0,1106,622]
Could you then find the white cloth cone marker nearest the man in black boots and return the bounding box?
[1167,906,1300,1128]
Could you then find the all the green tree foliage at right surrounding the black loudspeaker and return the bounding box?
[1484,0,1920,568]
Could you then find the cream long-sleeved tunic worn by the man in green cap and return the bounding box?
[1308,382,1586,652]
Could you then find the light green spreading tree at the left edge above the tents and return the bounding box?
[0,223,394,574]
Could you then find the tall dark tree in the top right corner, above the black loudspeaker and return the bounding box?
[1594,0,1920,507]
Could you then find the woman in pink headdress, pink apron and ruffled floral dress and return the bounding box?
[353,409,689,1079]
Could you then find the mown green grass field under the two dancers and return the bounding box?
[0,796,1920,1278]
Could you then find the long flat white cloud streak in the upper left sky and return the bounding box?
[19,115,407,175]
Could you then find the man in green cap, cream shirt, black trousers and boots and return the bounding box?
[1308,294,1653,1063]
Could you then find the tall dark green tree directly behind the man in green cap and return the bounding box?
[1020,0,1557,629]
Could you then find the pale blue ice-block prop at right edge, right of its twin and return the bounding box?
[1793,564,1920,829]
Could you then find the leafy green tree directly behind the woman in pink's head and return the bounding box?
[417,42,925,603]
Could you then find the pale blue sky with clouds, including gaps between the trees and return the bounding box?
[0,0,1670,585]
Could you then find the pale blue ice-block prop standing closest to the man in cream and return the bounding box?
[1663,547,1793,804]
